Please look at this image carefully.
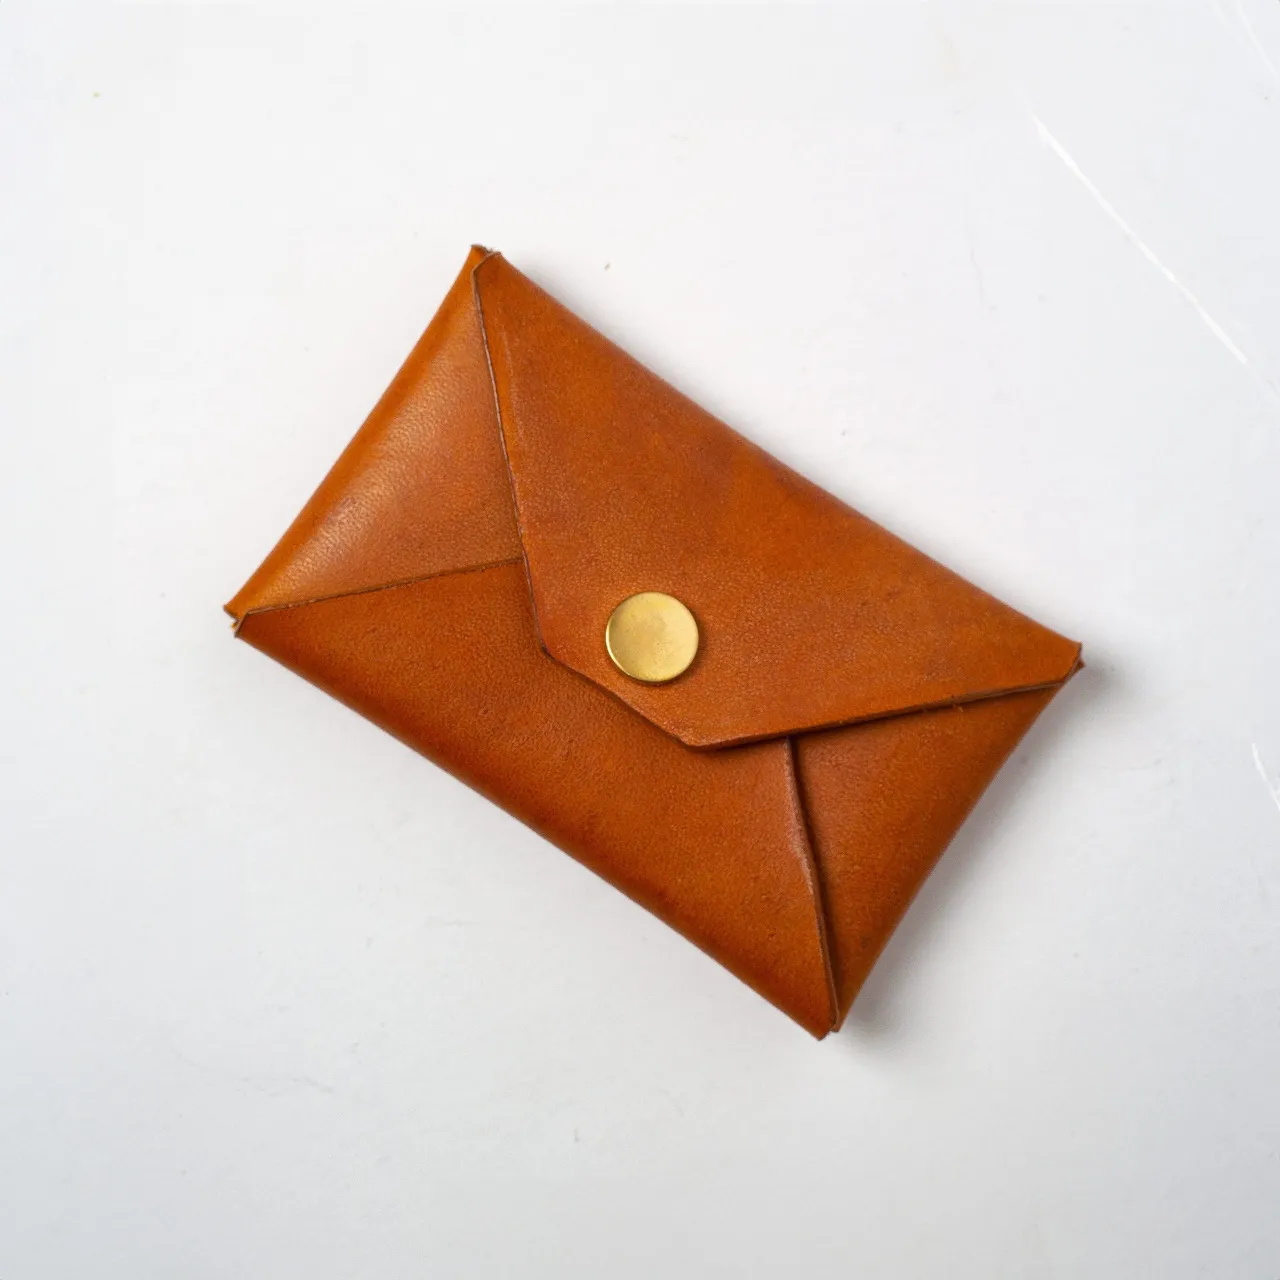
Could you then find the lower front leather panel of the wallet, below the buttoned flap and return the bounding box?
[239,563,833,1036]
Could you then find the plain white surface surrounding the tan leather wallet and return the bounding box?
[0,0,1280,1280]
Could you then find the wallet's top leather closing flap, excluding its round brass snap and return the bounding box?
[474,255,1079,748]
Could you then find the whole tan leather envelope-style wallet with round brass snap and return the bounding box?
[227,248,1080,1037]
